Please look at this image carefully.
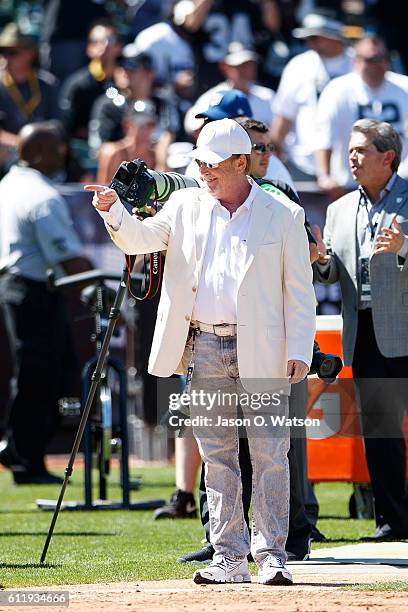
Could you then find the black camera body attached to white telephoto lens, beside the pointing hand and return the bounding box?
[109,159,155,208]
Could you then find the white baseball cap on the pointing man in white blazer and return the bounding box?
[189,119,252,164]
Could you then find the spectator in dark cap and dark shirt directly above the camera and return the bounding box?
[89,46,179,170]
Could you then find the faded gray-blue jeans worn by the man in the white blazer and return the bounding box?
[190,332,289,565]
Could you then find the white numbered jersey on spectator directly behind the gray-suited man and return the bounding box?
[313,72,408,187]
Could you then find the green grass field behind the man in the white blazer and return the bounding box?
[0,466,380,588]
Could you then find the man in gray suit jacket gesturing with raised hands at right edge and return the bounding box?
[314,119,408,541]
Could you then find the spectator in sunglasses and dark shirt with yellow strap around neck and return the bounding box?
[59,19,122,140]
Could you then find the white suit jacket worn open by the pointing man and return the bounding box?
[110,186,316,392]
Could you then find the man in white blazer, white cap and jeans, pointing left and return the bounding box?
[86,119,315,584]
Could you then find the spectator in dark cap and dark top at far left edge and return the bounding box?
[0,23,58,175]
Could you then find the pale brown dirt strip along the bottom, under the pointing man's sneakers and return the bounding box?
[0,560,408,612]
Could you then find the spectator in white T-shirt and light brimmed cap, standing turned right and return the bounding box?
[271,13,352,180]
